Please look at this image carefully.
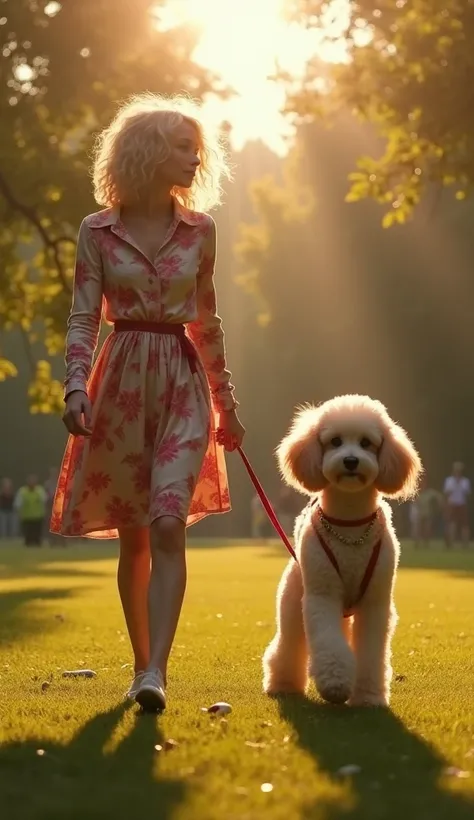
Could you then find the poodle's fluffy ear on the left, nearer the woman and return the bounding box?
[277,407,327,494]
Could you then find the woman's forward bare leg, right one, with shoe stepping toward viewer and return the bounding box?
[148,515,186,684]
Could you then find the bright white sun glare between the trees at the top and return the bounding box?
[156,0,347,154]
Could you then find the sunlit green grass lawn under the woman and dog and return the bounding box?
[0,543,474,820]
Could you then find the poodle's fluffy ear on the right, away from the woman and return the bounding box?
[375,422,423,501]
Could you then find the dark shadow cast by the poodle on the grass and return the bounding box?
[279,696,474,820]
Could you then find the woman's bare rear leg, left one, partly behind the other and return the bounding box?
[117,527,150,672]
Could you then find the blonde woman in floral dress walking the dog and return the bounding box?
[51,94,245,711]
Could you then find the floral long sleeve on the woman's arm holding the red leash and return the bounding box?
[188,217,237,410]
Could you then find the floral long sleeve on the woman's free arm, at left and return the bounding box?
[64,221,103,396]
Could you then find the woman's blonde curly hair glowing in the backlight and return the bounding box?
[92,93,230,211]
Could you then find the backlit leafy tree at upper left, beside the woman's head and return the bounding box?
[0,0,224,412]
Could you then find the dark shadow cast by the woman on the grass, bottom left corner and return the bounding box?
[0,705,186,820]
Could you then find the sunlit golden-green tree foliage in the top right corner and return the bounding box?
[288,0,474,226]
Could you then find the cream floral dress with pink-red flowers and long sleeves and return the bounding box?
[51,201,236,538]
